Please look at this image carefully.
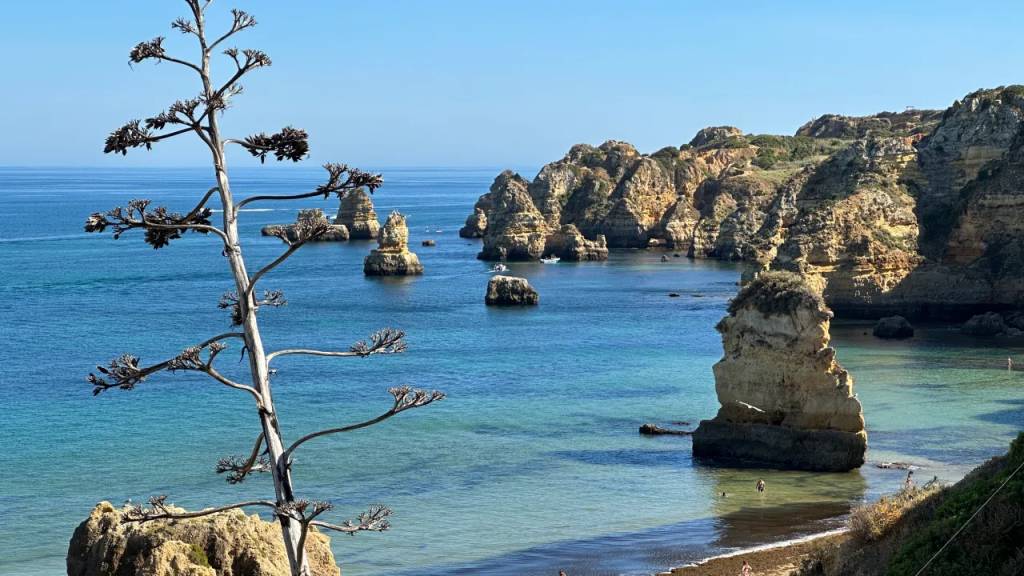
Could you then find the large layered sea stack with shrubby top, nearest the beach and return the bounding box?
[693,272,867,471]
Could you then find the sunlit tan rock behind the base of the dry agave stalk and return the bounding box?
[68,502,341,576]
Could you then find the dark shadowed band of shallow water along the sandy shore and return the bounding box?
[387,502,850,576]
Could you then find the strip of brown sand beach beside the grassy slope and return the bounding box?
[663,533,847,576]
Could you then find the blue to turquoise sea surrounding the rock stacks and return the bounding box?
[0,163,1024,576]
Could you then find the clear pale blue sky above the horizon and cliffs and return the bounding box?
[0,0,1024,166]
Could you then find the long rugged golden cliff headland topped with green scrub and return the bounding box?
[465,86,1024,318]
